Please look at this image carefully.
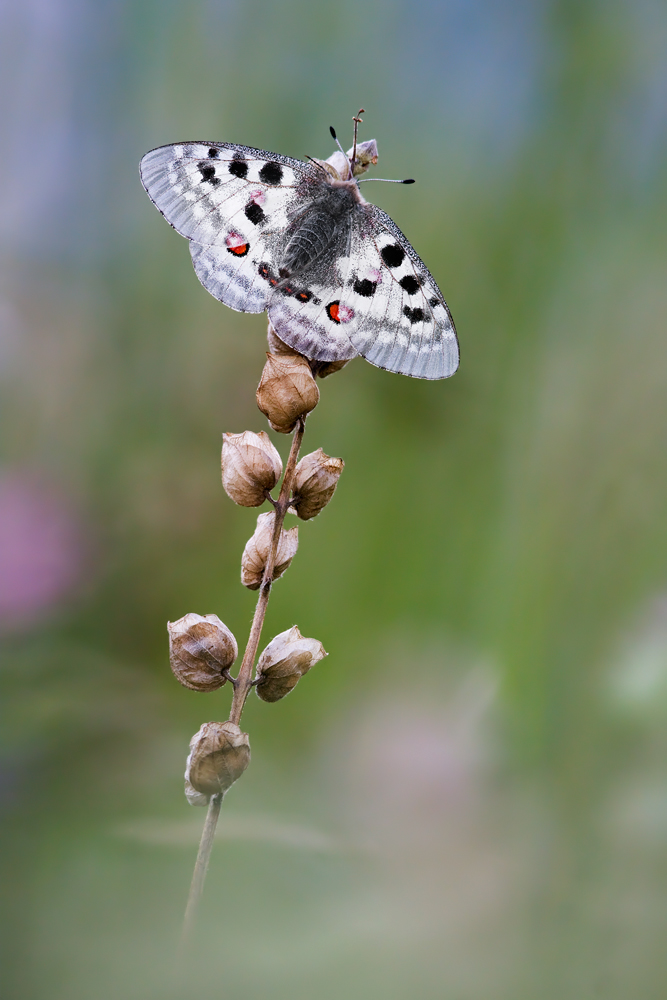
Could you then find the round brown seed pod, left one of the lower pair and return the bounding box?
[167,612,239,691]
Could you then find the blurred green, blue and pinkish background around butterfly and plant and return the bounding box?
[0,0,667,1000]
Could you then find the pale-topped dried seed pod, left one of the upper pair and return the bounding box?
[222,431,283,507]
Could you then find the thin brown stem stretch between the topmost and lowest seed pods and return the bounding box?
[229,417,306,726]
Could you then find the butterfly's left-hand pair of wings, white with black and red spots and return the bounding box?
[140,142,322,312]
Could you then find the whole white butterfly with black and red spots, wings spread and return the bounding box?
[140,112,459,379]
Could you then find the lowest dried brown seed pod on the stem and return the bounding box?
[185,722,250,805]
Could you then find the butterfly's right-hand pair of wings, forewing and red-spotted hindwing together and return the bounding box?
[268,204,459,379]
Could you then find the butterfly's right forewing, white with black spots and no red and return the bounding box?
[341,205,459,379]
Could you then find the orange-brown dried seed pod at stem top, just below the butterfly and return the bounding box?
[257,354,320,434]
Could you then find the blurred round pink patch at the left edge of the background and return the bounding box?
[0,473,83,629]
